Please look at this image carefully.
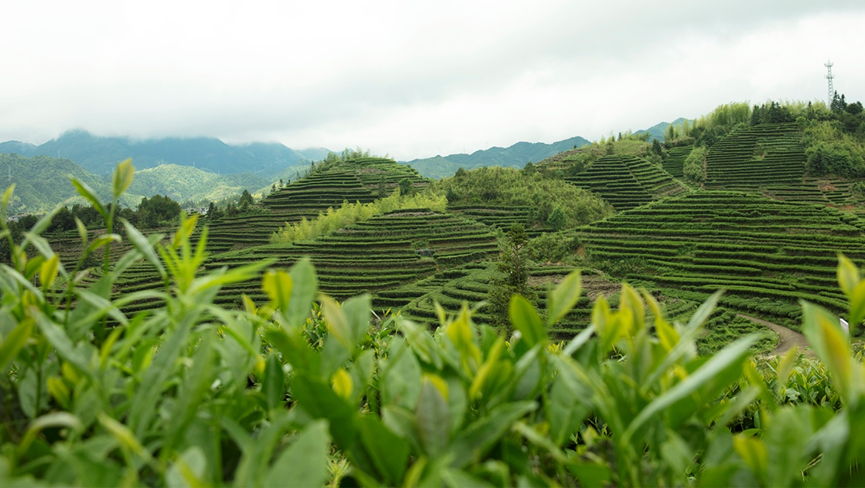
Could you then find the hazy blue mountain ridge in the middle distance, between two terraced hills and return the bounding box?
[403,137,590,178]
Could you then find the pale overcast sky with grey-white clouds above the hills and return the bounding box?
[0,0,865,160]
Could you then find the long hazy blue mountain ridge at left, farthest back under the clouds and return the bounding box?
[0,130,326,175]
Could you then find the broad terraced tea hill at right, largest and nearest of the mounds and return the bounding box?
[578,191,865,327]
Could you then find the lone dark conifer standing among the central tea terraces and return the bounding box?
[489,224,537,326]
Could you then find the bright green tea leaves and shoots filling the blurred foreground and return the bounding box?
[0,166,865,486]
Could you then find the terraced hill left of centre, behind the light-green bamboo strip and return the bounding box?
[198,158,427,252]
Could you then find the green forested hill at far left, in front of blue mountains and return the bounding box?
[0,154,141,215]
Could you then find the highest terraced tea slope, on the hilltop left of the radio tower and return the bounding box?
[705,123,805,190]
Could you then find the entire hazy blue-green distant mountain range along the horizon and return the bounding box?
[0,118,684,213]
